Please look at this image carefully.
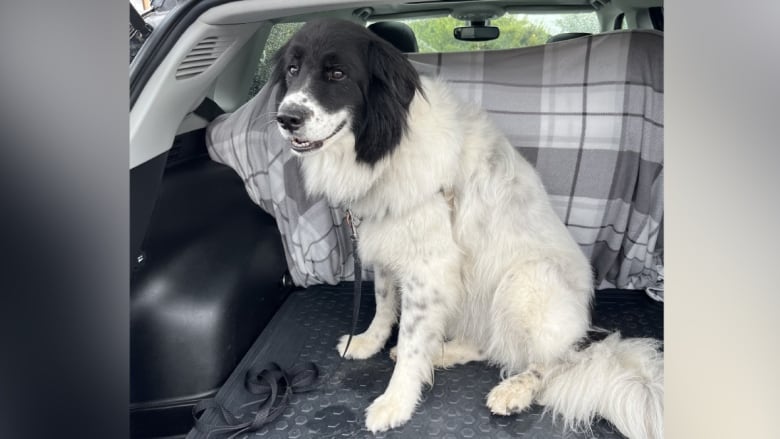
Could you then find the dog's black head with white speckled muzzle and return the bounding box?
[271,19,420,165]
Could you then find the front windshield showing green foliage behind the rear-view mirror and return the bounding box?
[399,12,600,53]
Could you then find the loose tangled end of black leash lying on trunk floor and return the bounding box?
[192,362,319,439]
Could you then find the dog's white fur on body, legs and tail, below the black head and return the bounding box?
[288,78,663,438]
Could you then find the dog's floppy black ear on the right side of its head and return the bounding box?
[356,40,421,164]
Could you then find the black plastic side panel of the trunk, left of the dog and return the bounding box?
[130,143,289,437]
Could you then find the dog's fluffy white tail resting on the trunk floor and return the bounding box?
[538,333,664,439]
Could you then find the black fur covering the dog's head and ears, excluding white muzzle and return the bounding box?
[270,19,422,165]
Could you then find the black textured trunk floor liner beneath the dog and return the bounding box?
[187,283,663,439]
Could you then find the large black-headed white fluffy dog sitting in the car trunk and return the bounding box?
[271,19,663,439]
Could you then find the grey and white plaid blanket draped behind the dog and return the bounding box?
[207,31,663,288]
